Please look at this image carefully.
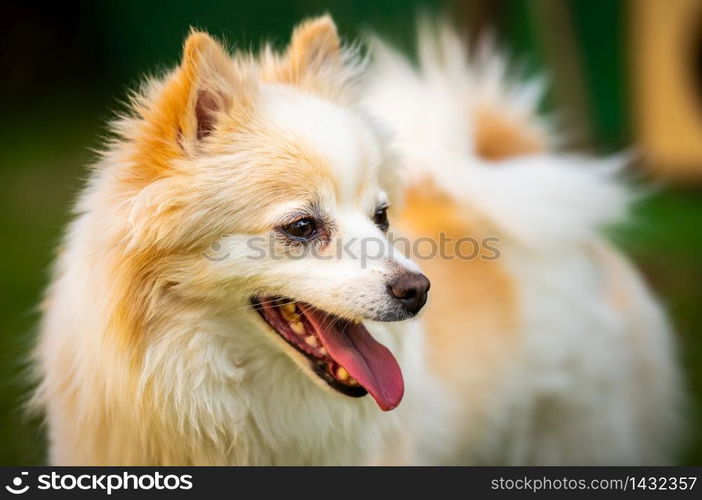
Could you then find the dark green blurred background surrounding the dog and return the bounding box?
[0,0,702,464]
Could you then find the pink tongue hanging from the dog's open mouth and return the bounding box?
[303,307,405,411]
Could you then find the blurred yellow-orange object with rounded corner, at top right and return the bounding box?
[629,0,702,182]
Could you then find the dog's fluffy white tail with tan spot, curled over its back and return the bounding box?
[366,19,631,247]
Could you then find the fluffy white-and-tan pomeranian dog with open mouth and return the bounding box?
[34,16,680,465]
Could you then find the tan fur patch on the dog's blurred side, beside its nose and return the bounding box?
[393,184,518,382]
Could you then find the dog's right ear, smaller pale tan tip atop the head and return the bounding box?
[287,15,342,78]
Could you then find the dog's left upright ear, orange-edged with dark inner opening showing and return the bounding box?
[177,31,237,143]
